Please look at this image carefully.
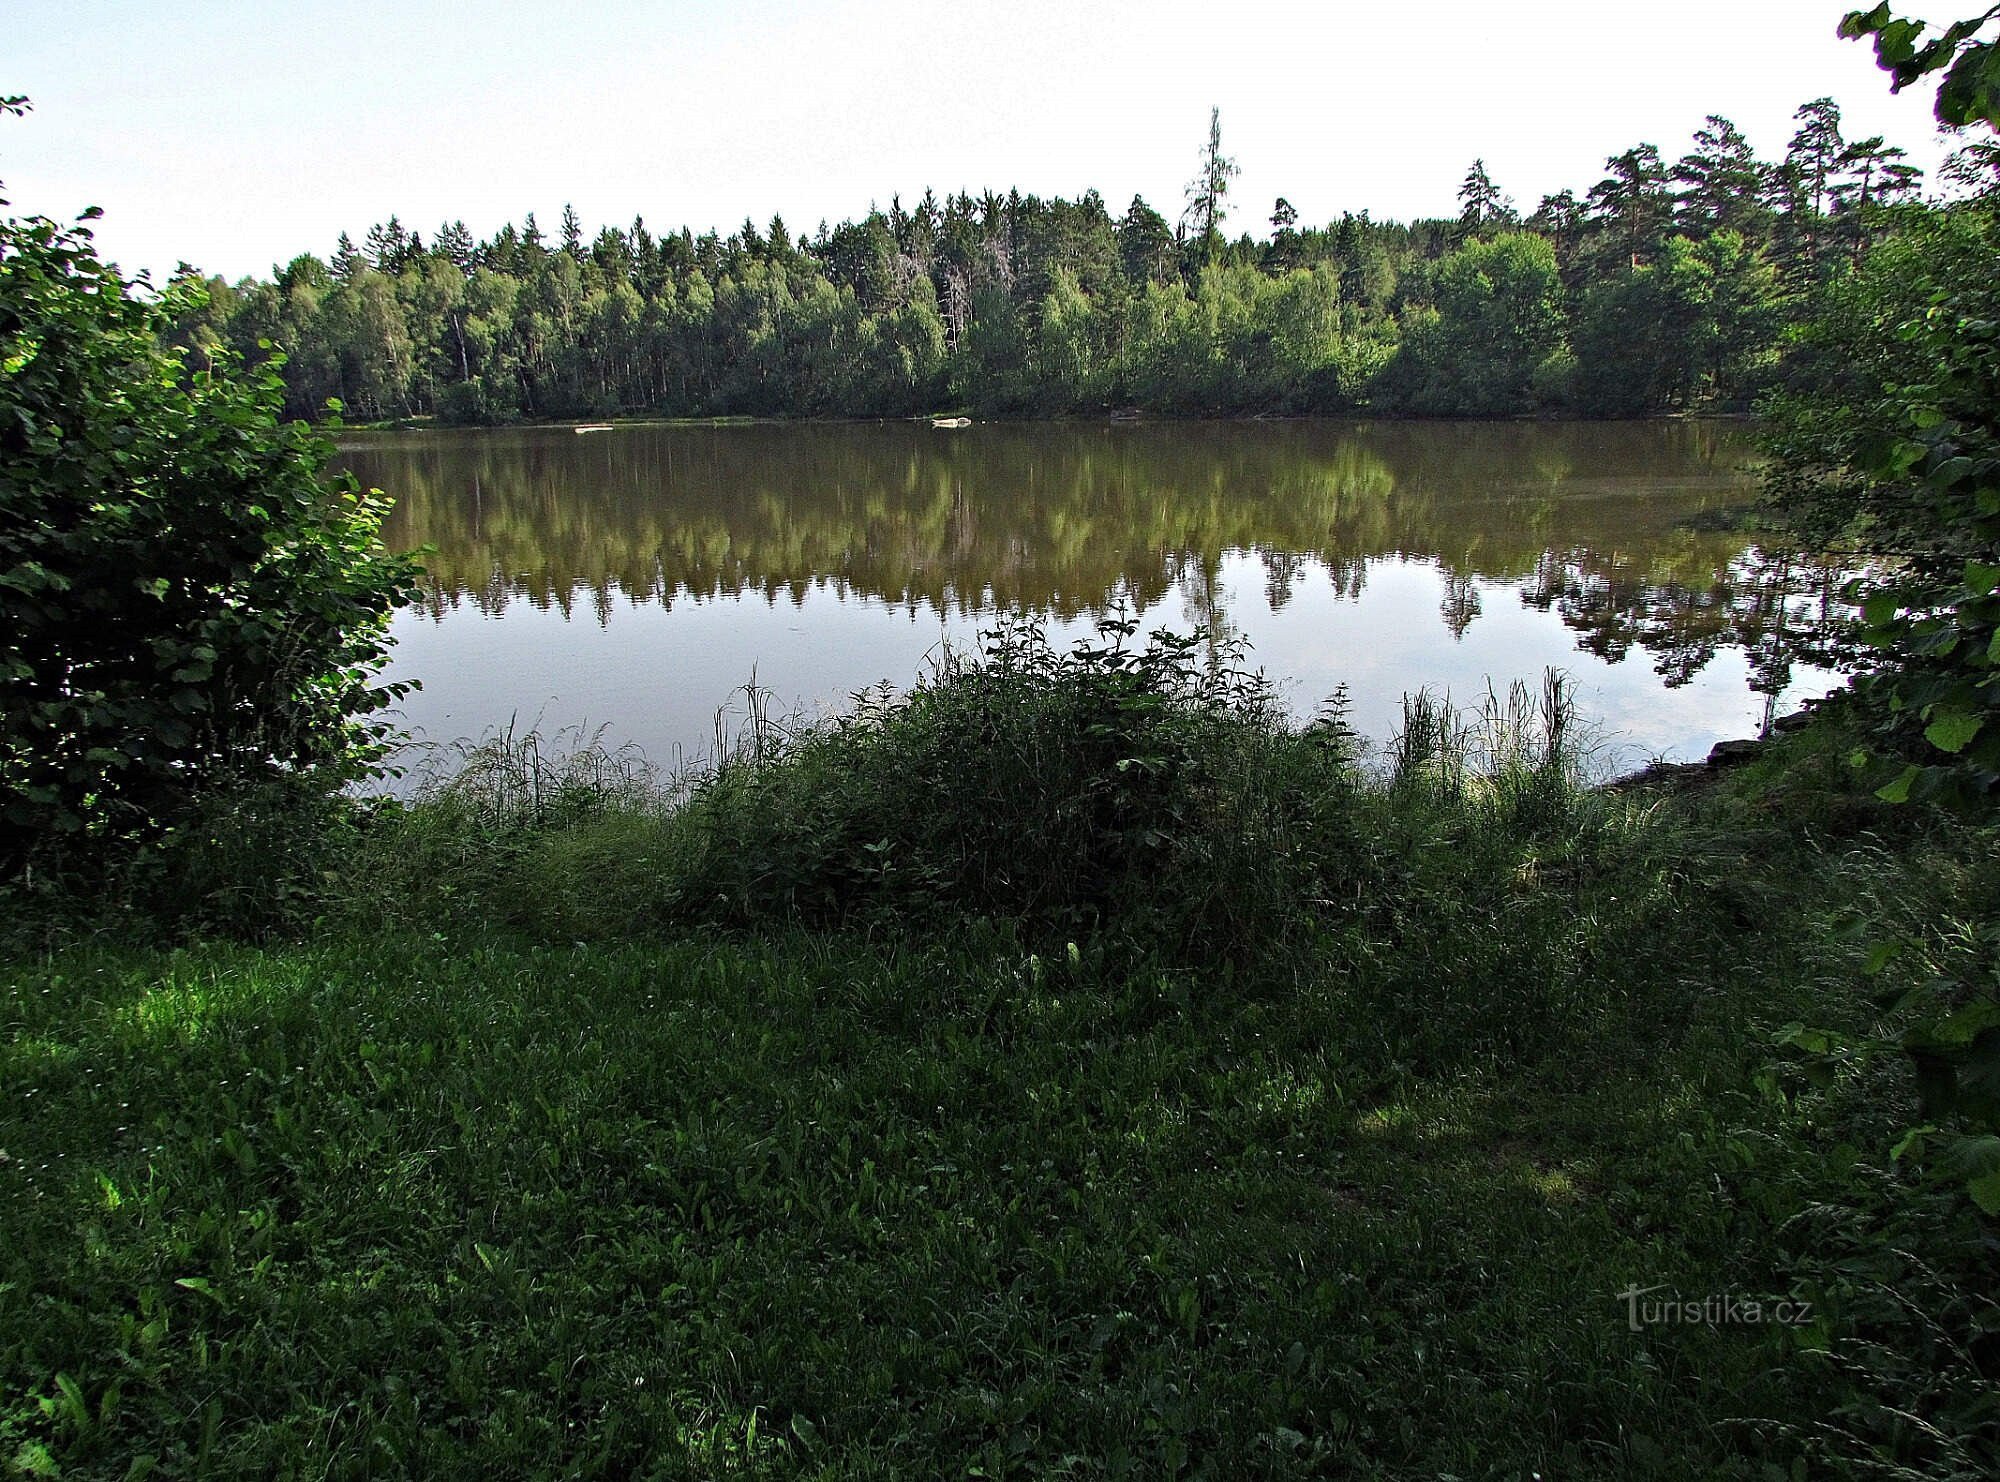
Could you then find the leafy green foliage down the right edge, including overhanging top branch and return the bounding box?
[1766,28,2000,1478]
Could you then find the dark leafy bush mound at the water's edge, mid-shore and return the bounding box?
[690,620,1348,942]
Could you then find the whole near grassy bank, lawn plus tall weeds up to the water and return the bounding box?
[0,634,1996,1478]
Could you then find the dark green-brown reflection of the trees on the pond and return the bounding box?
[344,422,1842,752]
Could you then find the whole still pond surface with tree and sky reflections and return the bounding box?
[342,422,1834,766]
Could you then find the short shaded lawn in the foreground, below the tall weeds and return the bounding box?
[0,912,1840,1476]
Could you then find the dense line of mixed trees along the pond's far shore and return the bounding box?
[178,98,1990,422]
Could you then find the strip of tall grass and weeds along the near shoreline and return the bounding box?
[340,618,1640,984]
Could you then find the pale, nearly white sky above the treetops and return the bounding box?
[0,0,1976,278]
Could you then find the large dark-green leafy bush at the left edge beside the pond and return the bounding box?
[0,204,414,874]
